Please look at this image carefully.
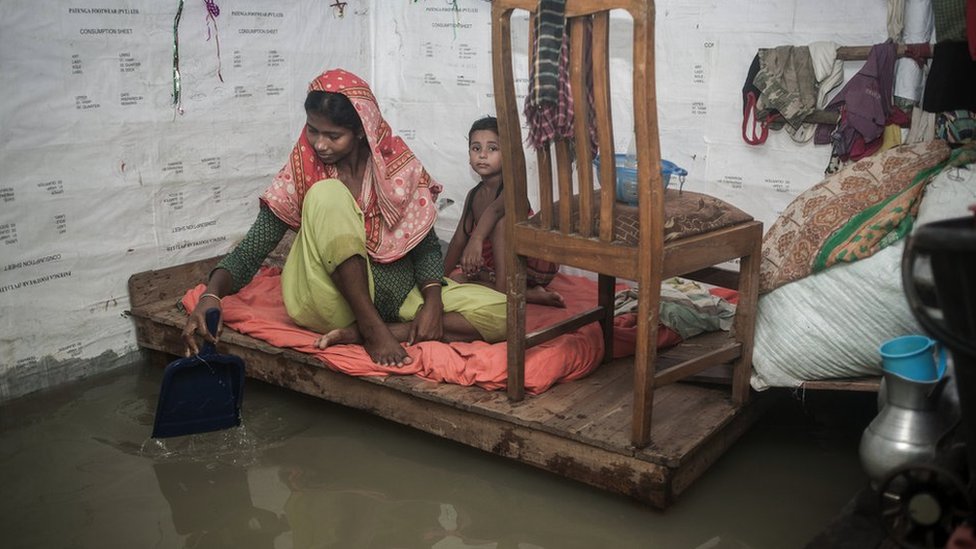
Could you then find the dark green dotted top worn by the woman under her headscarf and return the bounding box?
[217,199,444,322]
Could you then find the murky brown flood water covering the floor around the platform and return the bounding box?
[0,365,875,549]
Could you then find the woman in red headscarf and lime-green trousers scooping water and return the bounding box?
[183,69,505,367]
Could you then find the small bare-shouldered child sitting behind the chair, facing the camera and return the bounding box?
[444,116,566,307]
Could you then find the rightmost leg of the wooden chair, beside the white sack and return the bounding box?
[732,224,762,406]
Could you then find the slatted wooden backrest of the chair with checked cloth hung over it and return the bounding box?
[492,0,664,276]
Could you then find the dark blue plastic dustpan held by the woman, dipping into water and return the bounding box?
[152,308,244,438]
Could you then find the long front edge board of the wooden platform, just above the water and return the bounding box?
[135,304,670,507]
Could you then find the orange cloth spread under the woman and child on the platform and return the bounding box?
[183,267,681,394]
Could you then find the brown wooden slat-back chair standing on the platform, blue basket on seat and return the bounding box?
[492,0,762,447]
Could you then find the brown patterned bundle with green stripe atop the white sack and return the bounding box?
[759,140,949,293]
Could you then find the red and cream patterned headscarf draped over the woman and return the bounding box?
[261,69,441,263]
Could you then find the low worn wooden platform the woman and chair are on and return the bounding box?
[129,258,768,509]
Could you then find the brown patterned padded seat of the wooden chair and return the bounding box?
[529,189,753,246]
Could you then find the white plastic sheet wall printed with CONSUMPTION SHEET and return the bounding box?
[0,0,886,400]
